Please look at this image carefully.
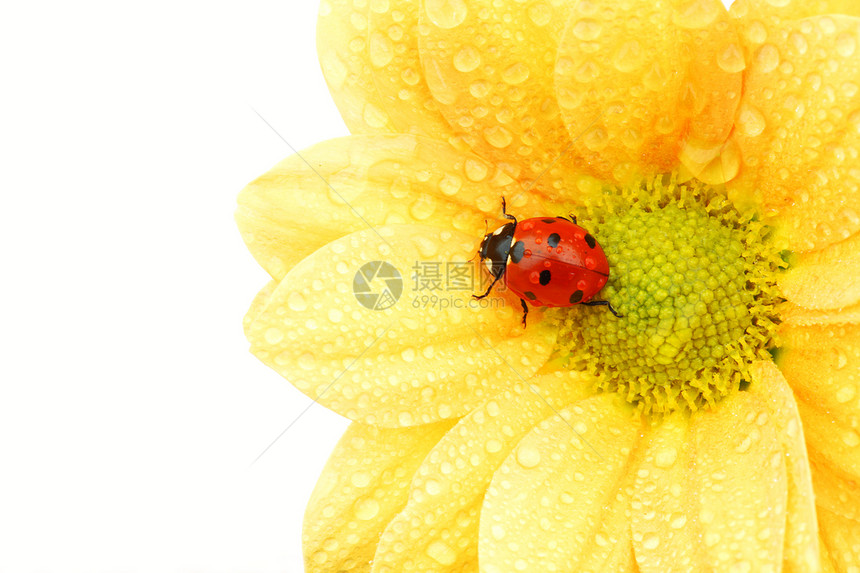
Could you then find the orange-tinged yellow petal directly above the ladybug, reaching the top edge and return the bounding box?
[419,0,596,203]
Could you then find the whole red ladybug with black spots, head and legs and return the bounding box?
[472,197,622,326]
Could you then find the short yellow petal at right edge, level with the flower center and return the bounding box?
[778,233,860,309]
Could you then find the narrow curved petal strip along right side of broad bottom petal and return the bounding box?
[750,362,820,573]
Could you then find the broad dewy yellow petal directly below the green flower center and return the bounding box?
[632,386,786,571]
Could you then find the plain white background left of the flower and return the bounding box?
[0,0,347,573]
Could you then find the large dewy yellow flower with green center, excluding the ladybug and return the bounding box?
[237,0,860,573]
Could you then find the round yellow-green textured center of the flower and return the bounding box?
[560,179,782,414]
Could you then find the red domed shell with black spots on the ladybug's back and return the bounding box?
[505,217,609,306]
